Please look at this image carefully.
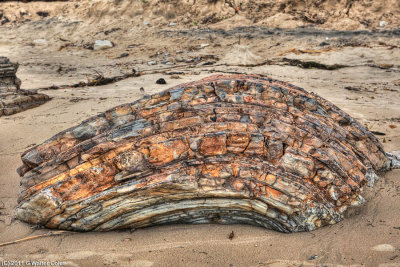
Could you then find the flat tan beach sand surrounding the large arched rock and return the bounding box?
[0,1,400,266]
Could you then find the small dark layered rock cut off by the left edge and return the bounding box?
[0,57,49,117]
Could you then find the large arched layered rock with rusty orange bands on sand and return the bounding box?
[16,75,391,232]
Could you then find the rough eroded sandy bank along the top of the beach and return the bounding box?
[0,0,400,30]
